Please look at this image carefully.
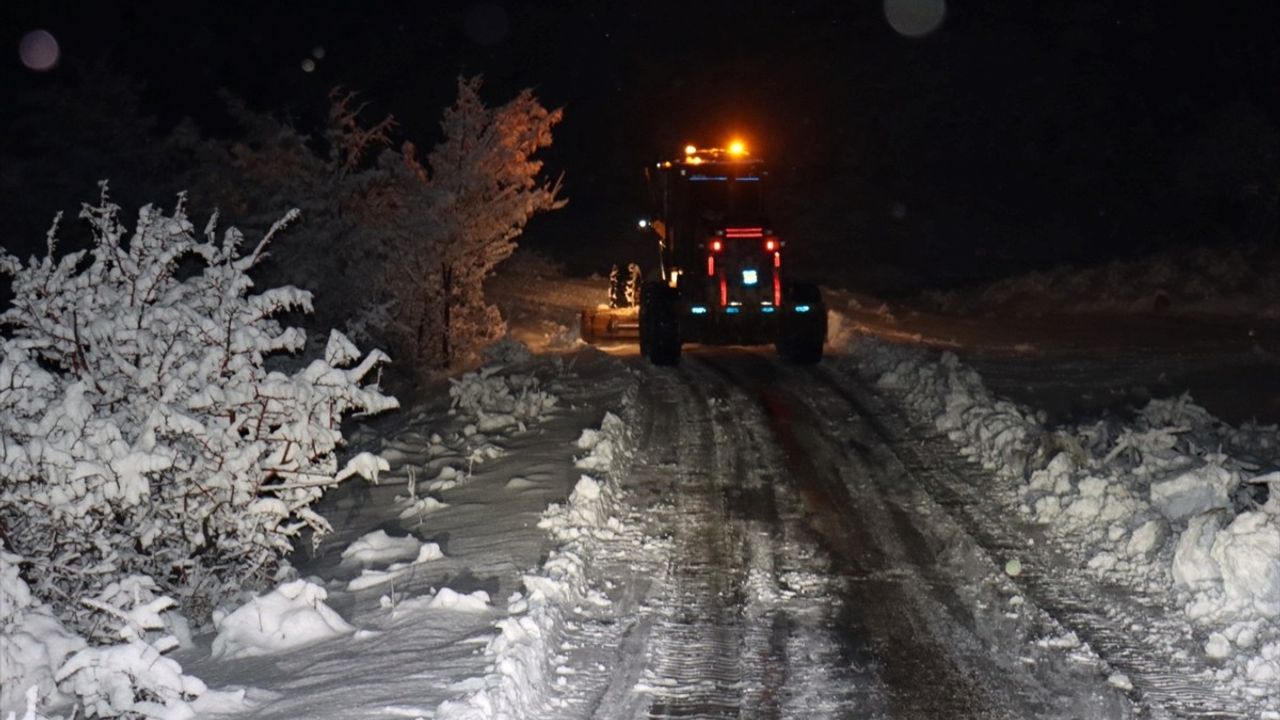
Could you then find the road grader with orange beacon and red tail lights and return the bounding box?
[581,142,827,365]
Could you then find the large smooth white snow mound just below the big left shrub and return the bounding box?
[212,580,356,660]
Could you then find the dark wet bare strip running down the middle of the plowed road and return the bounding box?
[699,352,1021,717]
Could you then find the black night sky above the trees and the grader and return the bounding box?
[0,0,1280,292]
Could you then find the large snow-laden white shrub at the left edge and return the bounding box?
[0,190,397,628]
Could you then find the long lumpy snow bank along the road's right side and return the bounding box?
[852,340,1280,705]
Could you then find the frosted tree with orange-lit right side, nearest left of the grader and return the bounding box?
[380,77,566,368]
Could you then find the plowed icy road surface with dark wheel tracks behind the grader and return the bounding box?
[576,348,1134,717]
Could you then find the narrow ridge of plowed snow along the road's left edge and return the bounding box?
[436,413,632,720]
